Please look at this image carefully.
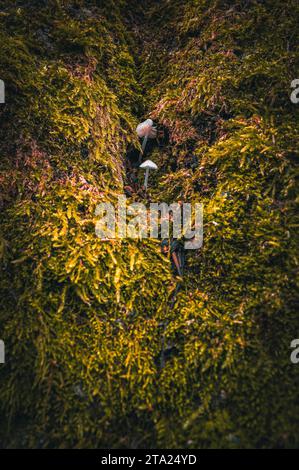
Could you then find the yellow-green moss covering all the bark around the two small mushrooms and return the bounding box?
[0,0,299,448]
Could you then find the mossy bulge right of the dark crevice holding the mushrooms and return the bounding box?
[145,1,298,447]
